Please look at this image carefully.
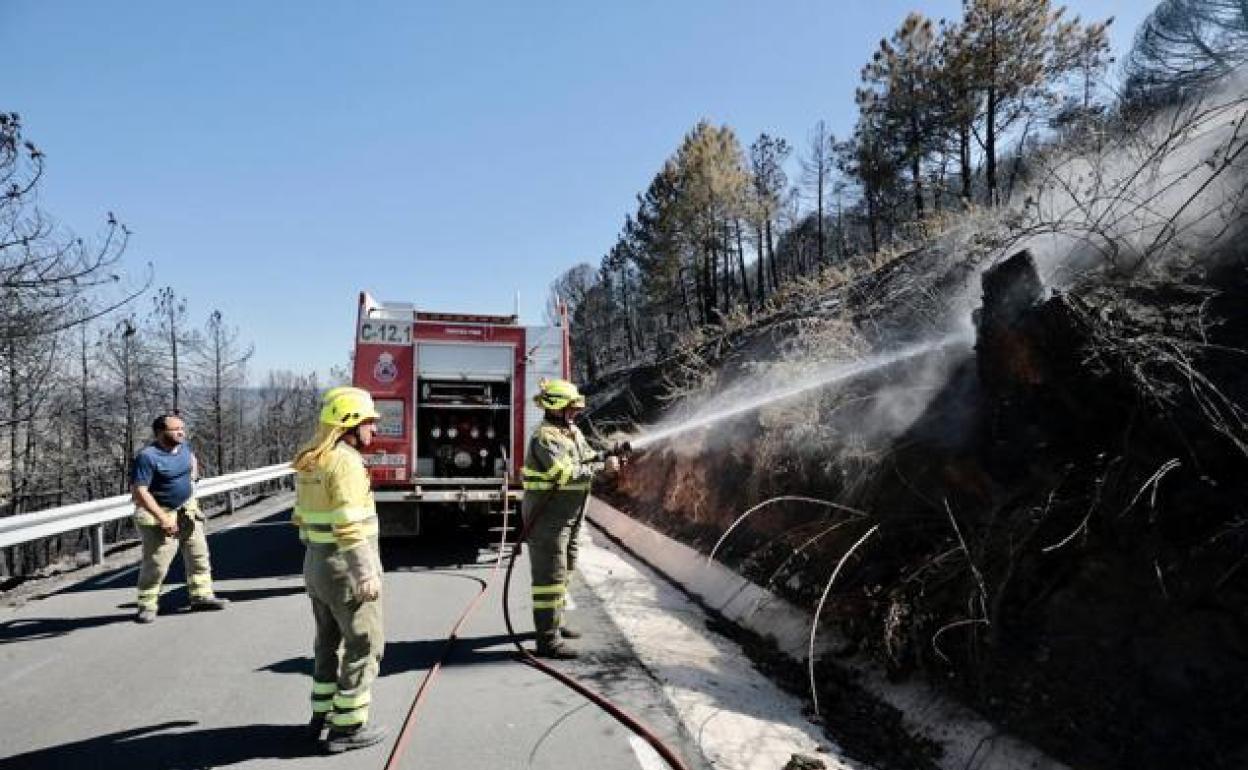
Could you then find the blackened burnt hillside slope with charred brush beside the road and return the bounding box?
[592,243,1248,769]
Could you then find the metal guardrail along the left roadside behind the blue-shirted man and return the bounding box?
[0,463,295,564]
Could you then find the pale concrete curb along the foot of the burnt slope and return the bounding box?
[588,498,1071,770]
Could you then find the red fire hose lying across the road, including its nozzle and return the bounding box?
[386,443,688,770]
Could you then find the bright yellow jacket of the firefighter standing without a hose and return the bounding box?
[291,442,377,552]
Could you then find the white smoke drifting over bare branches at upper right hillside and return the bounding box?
[1000,72,1248,288]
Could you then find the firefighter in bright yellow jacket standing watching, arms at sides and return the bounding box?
[291,388,386,754]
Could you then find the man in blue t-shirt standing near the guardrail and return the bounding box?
[130,414,228,623]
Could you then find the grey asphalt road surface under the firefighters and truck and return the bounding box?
[0,499,706,770]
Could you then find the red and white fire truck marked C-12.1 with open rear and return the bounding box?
[352,292,570,537]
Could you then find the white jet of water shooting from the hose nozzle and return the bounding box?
[628,331,970,454]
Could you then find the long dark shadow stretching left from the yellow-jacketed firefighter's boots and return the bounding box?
[0,721,319,770]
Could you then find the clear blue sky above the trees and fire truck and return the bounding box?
[0,0,1152,374]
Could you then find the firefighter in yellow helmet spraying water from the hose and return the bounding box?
[524,379,619,659]
